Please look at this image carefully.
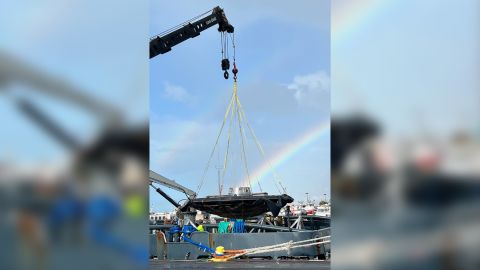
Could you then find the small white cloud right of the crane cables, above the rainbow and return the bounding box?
[287,70,330,108]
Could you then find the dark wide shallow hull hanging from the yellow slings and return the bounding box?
[182,194,293,219]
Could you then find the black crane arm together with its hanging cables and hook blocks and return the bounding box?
[150,6,234,79]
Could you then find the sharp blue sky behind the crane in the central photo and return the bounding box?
[150,1,330,211]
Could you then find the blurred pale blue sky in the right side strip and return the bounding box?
[331,0,480,139]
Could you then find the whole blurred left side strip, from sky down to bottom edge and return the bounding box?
[0,1,148,269]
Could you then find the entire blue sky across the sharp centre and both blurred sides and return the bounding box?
[0,0,472,215]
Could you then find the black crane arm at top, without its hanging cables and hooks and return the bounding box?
[150,6,234,59]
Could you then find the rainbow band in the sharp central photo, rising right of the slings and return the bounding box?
[241,121,330,186]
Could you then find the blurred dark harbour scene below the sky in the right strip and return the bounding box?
[332,115,480,269]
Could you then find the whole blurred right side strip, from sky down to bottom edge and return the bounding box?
[331,0,480,269]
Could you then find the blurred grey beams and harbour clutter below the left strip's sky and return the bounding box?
[0,49,148,269]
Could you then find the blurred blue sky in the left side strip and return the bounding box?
[0,0,148,167]
